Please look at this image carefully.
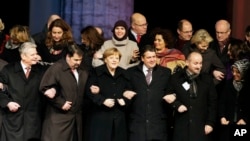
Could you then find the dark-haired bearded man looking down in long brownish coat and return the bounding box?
[40,44,88,141]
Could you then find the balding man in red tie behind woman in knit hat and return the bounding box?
[128,13,153,50]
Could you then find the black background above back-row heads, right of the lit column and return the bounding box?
[134,0,232,35]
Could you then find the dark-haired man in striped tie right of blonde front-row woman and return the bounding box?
[124,45,171,141]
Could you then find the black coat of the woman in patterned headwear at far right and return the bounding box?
[218,79,250,141]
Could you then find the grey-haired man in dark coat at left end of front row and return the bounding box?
[0,42,45,141]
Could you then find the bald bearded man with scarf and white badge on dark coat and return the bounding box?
[164,52,217,141]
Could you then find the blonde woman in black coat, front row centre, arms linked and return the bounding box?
[87,48,133,141]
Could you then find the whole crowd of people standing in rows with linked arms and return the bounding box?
[0,13,250,141]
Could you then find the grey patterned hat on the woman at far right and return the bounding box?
[232,59,250,77]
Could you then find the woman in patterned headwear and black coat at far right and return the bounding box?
[219,59,250,141]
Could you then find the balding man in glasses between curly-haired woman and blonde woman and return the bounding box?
[175,19,193,52]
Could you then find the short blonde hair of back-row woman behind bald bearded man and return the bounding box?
[191,29,213,45]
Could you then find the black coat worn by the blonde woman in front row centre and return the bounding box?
[87,64,129,141]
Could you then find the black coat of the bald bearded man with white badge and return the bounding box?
[170,69,217,141]
